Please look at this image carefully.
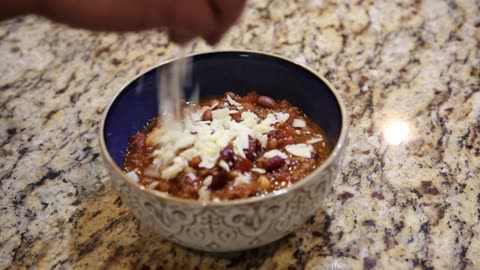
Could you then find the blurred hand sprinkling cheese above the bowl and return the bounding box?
[35,0,246,44]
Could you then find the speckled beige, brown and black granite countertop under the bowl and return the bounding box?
[0,0,480,269]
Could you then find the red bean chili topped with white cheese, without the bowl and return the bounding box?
[123,92,330,201]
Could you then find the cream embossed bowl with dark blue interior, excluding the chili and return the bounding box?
[100,51,348,252]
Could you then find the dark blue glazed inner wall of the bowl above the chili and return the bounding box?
[103,52,342,167]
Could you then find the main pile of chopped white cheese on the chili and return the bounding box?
[151,100,290,182]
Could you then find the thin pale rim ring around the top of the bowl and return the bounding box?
[99,50,350,207]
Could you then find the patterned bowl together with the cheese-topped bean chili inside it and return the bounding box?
[100,51,348,252]
